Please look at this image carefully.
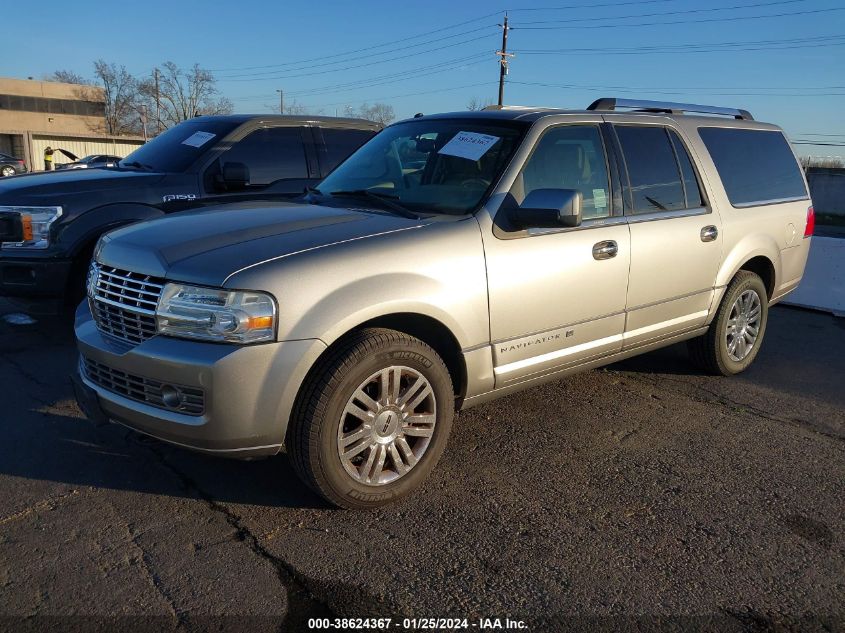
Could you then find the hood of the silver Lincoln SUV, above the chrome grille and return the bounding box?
[97,202,425,286]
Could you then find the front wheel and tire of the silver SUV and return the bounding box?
[287,328,455,510]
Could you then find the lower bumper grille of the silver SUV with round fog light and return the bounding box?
[80,357,205,415]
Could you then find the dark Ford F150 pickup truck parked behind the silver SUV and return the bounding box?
[0,115,381,311]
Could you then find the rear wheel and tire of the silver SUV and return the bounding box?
[687,270,769,376]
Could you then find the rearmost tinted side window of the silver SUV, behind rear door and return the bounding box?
[698,127,807,207]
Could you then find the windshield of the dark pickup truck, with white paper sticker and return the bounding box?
[120,117,239,173]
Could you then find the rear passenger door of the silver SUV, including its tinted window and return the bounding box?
[613,119,722,348]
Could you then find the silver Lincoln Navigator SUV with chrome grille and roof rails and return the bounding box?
[76,99,813,508]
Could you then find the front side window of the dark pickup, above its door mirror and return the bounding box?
[220,127,308,185]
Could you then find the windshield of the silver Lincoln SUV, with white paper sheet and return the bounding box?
[319,119,526,214]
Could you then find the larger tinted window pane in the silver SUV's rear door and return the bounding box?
[616,126,686,213]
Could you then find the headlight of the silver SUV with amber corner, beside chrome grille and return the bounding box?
[156,283,276,343]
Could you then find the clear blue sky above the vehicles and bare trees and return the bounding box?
[6,0,845,156]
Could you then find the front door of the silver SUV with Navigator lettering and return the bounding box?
[485,121,631,387]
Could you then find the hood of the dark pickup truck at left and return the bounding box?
[0,169,164,206]
